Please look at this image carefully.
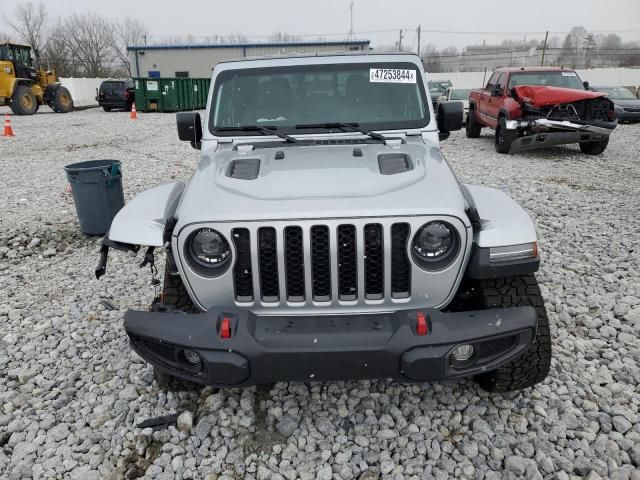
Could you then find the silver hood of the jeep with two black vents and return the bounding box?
[177,141,465,225]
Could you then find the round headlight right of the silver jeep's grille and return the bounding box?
[411,221,460,270]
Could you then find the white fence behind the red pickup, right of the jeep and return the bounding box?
[429,68,640,88]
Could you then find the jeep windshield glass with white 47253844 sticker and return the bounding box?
[209,63,429,136]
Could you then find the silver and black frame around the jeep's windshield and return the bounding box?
[207,59,431,138]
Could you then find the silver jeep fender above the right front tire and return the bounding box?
[465,185,537,248]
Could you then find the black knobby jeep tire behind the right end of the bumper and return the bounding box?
[474,275,551,392]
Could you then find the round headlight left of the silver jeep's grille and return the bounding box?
[186,228,231,275]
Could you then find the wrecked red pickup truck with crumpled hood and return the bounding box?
[467,67,617,155]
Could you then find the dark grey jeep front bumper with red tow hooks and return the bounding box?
[124,307,537,387]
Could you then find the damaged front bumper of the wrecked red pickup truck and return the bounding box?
[505,118,617,153]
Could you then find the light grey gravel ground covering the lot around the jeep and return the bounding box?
[0,108,640,480]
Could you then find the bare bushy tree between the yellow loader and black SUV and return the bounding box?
[61,14,115,77]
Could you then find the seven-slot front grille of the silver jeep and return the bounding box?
[232,223,411,303]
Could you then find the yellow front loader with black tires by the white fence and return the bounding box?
[0,43,73,115]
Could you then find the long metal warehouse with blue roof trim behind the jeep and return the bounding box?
[127,40,370,77]
